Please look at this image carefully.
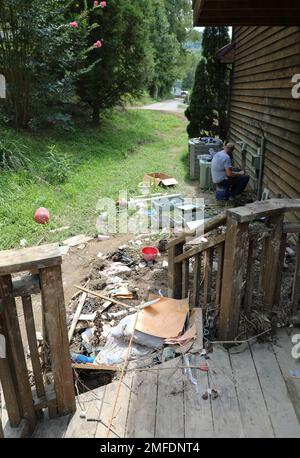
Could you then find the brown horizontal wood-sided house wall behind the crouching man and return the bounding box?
[229,27,300,202]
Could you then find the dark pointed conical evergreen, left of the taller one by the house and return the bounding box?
[185,58,214,138]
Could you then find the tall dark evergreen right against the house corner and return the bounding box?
[202,27,230,140]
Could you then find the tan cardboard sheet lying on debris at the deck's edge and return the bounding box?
[136,294,189,339]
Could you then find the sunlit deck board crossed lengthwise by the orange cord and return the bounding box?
[95,373,133,439]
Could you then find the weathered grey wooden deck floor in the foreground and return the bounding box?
[3,330,300,438]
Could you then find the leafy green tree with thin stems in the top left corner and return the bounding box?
[0,0,89,127]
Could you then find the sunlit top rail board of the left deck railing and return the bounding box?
[0,244,62,275]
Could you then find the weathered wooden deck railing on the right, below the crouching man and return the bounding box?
[169,199,300,341]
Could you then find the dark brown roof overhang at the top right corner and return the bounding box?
[193,0,300,26]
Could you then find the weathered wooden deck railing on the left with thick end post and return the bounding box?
[0,245,75,437]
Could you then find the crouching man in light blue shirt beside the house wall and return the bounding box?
[211,143,250,198]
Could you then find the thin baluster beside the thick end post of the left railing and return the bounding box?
[22,296,45,397]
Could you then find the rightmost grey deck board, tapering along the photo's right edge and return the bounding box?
[273,329,300,423]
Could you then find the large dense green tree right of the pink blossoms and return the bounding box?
[77,0,153,126]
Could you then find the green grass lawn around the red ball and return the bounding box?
[0,110,188,249]
